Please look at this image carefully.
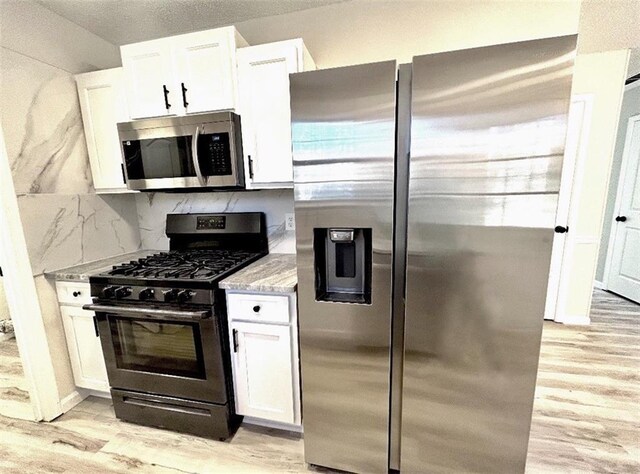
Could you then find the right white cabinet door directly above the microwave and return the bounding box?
[172,28,236,113]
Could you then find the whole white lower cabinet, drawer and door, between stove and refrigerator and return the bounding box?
[227,293,301,426]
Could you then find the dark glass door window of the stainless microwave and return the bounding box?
[122,136,196,179]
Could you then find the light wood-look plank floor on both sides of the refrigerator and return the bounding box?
[0,291,640,473]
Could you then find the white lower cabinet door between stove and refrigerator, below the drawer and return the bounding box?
[231,323,294,423]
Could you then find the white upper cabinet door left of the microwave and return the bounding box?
[76,68,129,192]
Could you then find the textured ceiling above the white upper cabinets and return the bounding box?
[37,0,345,46]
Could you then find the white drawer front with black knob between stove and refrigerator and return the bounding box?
[227,293,291,323]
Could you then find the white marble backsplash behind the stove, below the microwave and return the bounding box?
[136,189,296,253]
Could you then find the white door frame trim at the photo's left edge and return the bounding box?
[0,128,62,421]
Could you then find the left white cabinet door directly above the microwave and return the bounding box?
[120,39,174,119]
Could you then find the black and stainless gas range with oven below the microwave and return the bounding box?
[85,213,268,439]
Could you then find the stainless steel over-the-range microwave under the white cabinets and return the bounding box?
[118,112,244,191]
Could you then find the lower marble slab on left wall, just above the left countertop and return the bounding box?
[18,194,140,275]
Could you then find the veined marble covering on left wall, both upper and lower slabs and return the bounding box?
[0,41,140,275]
